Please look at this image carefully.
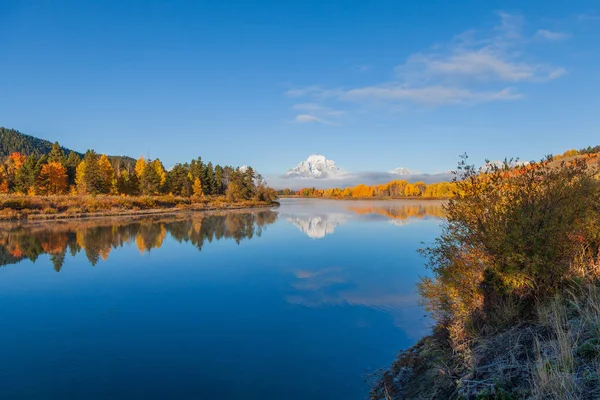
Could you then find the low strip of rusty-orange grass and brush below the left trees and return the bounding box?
[0,195,276,220]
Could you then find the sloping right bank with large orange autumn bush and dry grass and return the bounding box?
[371,160,600,400]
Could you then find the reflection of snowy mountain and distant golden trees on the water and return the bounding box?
[282,199,444,239]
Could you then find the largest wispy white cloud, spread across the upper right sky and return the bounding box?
[286,13,568,111]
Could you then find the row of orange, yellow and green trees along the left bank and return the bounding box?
[0,143,276,201]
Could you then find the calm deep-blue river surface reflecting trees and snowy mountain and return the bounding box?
[0,199,442,399]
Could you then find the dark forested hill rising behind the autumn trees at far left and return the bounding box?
[0,127,135,165]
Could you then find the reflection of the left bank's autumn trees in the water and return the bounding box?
[0,210,277,272]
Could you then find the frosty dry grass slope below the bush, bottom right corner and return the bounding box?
[371,284,600,400]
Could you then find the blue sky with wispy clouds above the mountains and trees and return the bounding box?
[0,0,600,175]
